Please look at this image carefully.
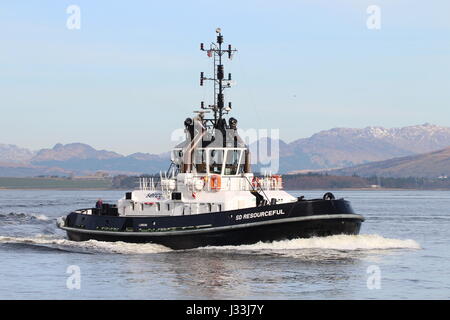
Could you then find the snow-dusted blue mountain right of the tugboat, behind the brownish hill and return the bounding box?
[280,124,450,171]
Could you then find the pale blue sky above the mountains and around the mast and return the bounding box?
[0,0,450,154]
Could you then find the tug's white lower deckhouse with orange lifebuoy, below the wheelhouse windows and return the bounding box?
[117,163,297,216]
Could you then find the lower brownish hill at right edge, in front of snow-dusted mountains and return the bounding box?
[328,148,450,178]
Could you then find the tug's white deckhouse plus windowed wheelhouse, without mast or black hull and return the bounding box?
[117,148,297,216]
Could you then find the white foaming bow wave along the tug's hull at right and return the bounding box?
[203,234,420,251]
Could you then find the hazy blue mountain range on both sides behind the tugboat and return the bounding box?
[0,124,450,176]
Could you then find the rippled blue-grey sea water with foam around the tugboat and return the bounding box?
[0,190,450,300]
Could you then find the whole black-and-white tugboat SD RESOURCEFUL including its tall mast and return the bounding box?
[57,28,364,249]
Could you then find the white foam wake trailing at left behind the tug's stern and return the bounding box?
[0,235,172,254]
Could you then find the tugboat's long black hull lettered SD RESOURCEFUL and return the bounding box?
[61,200,364,249]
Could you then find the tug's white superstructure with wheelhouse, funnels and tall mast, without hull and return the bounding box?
[111,28,297,216]
